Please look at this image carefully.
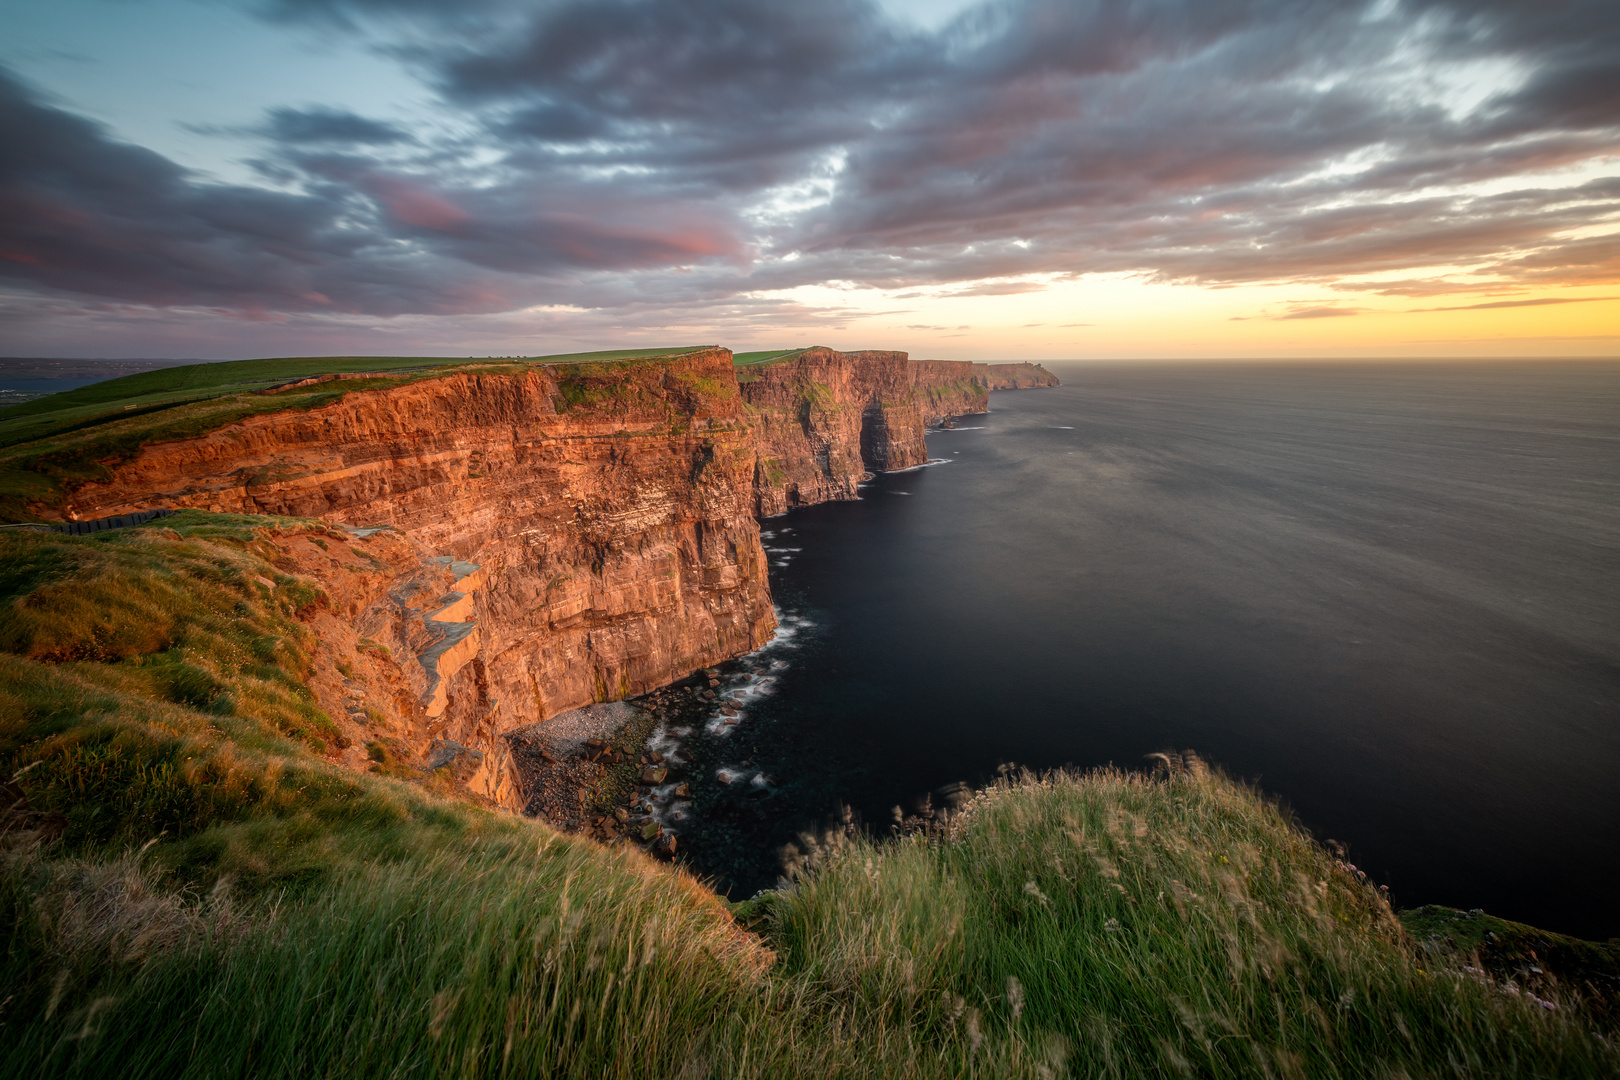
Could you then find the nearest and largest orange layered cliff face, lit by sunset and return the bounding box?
[68,350,776,799]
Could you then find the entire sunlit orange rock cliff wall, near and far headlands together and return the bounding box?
[50,348,1055,786]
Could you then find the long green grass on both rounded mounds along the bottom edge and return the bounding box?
[9,772,1617,1077]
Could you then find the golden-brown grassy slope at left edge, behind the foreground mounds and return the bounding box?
[0,510,367,852]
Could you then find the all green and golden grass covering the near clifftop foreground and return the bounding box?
[0,512,1620,1078]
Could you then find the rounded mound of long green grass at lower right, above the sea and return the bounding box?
[768,766,1620,1077]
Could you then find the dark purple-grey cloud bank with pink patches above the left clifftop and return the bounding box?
[0,71,751,317]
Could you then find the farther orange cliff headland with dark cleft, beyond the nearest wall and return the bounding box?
[739,348,990,515]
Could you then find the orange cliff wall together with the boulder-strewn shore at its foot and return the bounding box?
[44,348,1056,853]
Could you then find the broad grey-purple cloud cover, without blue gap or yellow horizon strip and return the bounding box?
[0,0,1620,317]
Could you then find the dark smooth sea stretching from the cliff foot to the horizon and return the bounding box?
[660,363,1620,938]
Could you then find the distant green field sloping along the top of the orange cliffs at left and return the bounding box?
[0,347,698,521]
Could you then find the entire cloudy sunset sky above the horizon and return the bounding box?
[0,0,1620,359]
